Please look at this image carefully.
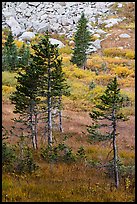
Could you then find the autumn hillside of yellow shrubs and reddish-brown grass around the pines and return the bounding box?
[2,2,135,202]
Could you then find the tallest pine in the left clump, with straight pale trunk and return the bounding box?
[28,32,67,146]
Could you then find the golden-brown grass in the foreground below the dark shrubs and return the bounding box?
[2,157,135,202]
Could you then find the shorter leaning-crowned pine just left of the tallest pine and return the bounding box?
[10,61,44,149]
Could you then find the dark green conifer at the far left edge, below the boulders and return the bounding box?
[2,31,18,71]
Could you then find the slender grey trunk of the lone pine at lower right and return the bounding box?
[112,110,119,188]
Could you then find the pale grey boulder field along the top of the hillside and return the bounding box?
[2,2,135,53]
